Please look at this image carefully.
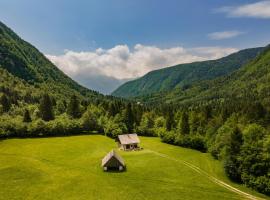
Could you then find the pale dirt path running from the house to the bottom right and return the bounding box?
[148,149,264,200]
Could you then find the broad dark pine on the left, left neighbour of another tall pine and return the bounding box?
[39,94,54,121]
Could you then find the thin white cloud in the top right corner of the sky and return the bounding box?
[216,1,270,19]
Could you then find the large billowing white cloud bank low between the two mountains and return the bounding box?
[47,44,237,93]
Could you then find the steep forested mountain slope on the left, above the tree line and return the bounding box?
[0,22,102,98]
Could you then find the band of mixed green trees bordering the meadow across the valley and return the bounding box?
[0,93,270,195]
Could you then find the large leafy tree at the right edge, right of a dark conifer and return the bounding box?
[240,124,270,194]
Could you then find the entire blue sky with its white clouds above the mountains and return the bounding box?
[0,0,270,94]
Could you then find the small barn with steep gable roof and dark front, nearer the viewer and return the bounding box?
[101,150,126,171]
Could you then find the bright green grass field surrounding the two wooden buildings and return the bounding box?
[0,135,269,200]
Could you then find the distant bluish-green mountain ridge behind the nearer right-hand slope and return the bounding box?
[112,47,263,98]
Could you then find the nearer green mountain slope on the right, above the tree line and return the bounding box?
[133,46,270,104]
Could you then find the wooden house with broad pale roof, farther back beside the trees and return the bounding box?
[118,133,140,151]
